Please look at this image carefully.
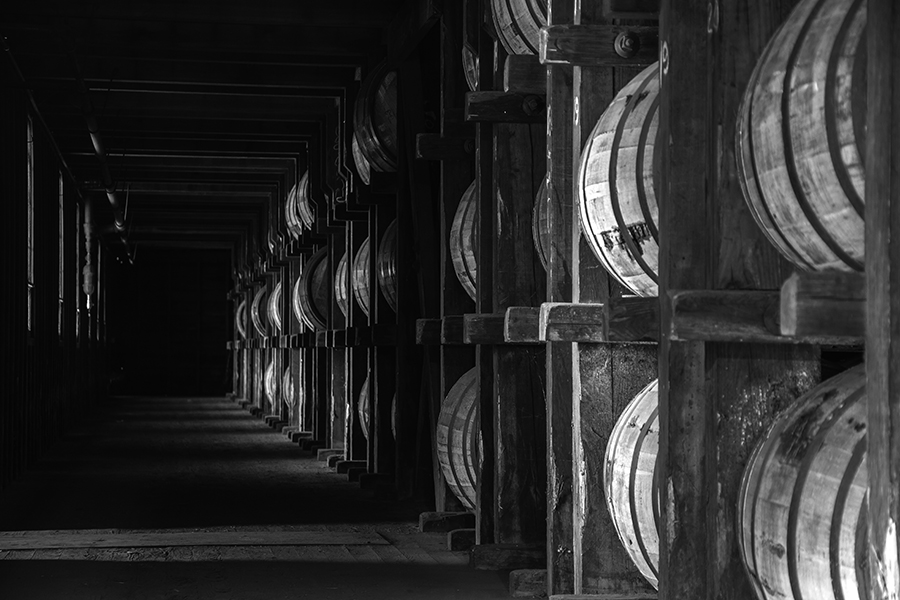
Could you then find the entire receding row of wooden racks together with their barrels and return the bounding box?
[231,0,900,599]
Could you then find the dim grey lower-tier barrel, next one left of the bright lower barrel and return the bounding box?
[435,369,481,510]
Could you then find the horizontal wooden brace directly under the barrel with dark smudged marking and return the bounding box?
[538,297,659,343]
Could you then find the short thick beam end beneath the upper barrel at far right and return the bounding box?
[781,271,866,342]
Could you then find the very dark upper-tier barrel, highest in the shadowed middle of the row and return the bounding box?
[353,63,397,172]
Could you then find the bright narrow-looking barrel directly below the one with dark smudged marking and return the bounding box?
[603,381,660,589]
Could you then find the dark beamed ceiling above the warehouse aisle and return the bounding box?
[0,0,413,264]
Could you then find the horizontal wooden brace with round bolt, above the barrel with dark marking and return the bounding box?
[540,25,659,67]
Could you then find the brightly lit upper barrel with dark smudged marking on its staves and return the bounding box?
[577,63,660,296]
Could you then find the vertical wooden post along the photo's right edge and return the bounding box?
[865,0,900,600]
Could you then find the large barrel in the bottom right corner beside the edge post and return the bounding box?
[738,365,869,600]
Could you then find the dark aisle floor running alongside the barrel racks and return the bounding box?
[0,398,508,600]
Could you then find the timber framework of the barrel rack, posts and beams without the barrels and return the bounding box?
[232,0,900,598]
